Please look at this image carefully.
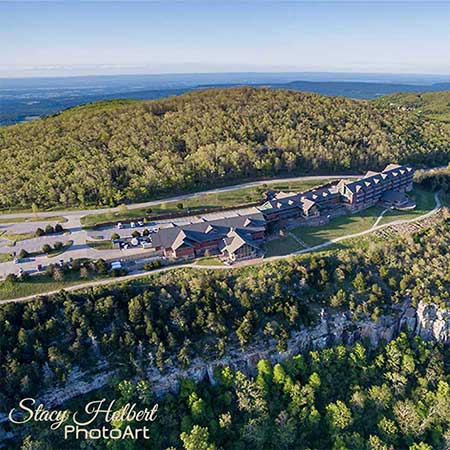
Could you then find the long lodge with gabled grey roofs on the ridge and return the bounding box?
[143,164,415,263]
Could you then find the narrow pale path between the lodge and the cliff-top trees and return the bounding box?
[0,193,442,304]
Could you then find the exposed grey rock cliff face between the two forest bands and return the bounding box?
[0,302,450,443]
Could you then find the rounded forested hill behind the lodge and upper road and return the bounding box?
[0,88,450,208]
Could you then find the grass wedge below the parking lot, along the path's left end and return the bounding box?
[0,272,100,300]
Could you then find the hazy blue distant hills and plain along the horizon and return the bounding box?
[0,73,450,125]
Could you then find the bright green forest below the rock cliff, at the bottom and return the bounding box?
[8,334,450,450]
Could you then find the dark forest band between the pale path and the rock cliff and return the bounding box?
[0,213,450,411]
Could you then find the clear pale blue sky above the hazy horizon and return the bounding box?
[0,0,450,76]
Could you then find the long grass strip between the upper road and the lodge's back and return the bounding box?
[81,179,336,227]
